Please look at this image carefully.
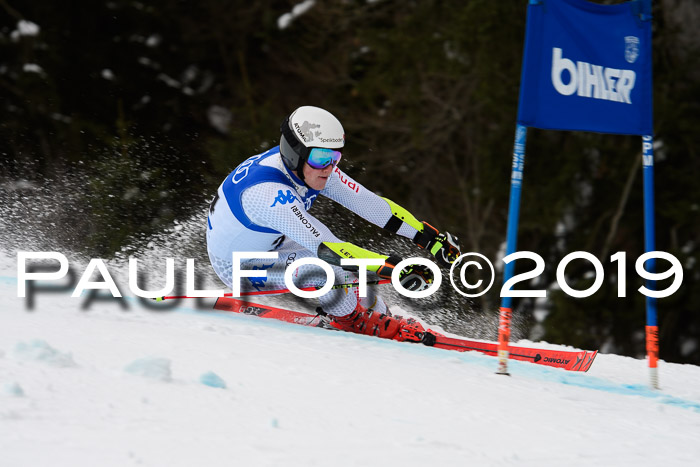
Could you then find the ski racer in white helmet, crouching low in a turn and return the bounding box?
[207,106,460,341]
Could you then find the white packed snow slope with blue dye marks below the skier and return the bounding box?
[0,255,700,467]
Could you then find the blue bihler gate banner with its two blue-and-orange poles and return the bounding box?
[498,0,658,387]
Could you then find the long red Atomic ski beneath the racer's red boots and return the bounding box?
[214,297,598,371]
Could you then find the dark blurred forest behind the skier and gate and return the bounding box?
[0,0,700,364]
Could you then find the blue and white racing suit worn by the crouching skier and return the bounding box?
[202,147,418,316]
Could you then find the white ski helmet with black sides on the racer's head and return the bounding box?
[280,105,345,173]
